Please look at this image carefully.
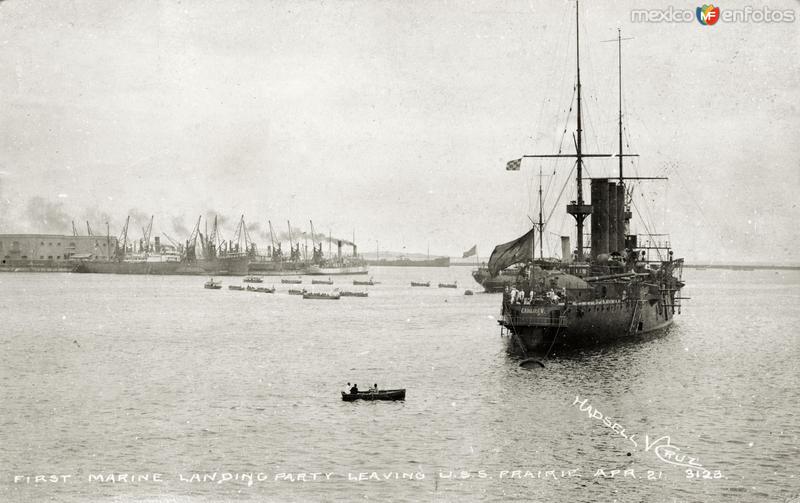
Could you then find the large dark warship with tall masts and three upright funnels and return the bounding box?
[494,2,684,356]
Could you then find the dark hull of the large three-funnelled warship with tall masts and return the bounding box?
[499,300,675,355]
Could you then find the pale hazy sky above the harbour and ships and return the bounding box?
[0,0,800,263]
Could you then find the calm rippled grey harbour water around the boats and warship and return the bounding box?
[0,267,800,502]
